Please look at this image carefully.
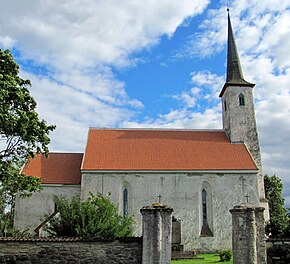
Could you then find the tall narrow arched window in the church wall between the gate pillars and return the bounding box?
[200,182,213,237]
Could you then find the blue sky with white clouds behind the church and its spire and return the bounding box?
[0,0,290,206]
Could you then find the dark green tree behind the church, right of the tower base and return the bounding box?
[264,175,289,237]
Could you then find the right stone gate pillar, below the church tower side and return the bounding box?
[230,204,266,264]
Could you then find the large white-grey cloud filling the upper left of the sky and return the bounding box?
[0,0,208,69]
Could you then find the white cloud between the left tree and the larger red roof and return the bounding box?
[25,73,139,151]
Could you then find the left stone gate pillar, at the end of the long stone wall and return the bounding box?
[140,204,173,264]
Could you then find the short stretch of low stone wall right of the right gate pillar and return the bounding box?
[266,238,290,264]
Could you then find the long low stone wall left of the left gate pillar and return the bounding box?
[0,238,142,264]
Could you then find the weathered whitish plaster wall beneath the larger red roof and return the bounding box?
[81,173,259,251]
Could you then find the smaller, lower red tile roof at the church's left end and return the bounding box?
[22,153,83,184]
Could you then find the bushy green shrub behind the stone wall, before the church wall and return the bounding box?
[47,193,134,239]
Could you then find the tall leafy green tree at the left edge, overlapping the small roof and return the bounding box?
[0,49,55,235]
